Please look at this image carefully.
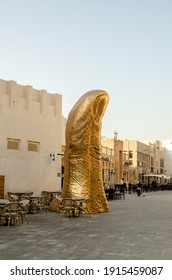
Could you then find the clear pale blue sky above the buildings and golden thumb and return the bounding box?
[0,0,172,140]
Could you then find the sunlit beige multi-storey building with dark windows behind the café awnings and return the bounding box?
[123,140,166,184]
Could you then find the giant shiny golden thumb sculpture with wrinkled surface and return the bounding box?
[62,90,109,213]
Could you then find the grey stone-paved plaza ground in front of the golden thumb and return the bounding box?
[0,191,172,260]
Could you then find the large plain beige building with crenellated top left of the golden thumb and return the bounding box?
[0,80,66,197]
